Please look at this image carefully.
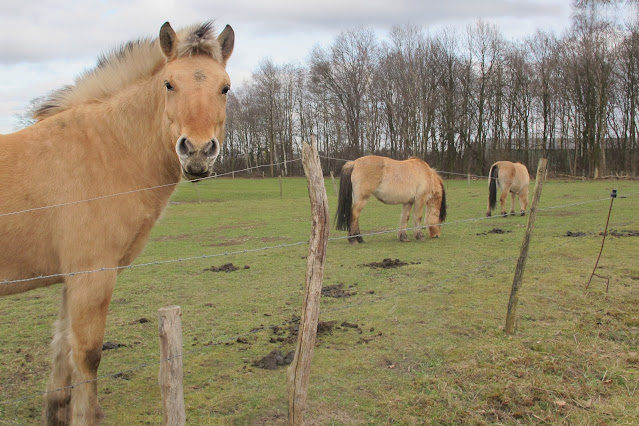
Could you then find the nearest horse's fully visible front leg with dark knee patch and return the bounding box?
[67,271,116,425]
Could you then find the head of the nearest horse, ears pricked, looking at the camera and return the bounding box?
[158,22,235,179]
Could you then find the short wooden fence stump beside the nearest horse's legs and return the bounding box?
[158,306,186,426]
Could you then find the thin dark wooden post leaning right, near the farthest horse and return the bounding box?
[505,158,548,334]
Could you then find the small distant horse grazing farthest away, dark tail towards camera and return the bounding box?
[486,161,530,216]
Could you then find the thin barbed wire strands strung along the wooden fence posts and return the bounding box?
[0,156,639,424]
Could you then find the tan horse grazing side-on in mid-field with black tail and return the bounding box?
[335,155,446,244]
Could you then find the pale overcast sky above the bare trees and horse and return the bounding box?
[0,0,571,133]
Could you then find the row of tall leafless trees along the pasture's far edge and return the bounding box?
[220,0,639,177]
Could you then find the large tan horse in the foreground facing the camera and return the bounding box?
[0,22,235,425]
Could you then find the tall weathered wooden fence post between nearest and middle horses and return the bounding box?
[286,136,330,425]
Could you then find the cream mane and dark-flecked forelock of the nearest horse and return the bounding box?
[33,21,223,121]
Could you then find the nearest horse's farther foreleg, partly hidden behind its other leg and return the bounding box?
[42,287,71,425]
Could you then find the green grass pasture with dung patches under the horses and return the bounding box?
[0,178,639,425]
